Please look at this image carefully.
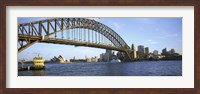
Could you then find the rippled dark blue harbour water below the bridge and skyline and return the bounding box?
[18,61,182,76]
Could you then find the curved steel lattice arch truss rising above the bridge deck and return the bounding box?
[18,18,130,49]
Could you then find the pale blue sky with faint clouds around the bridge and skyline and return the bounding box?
[18,18,182,60]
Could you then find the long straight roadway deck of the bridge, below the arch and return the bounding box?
[18,34,131,52]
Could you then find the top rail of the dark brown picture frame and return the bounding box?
[1,0,198,6]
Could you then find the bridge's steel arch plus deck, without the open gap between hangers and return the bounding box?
[18,18,130,57]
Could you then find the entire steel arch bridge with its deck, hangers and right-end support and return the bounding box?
[18,18,133,60]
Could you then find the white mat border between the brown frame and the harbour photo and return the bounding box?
[6,6,194,88]
